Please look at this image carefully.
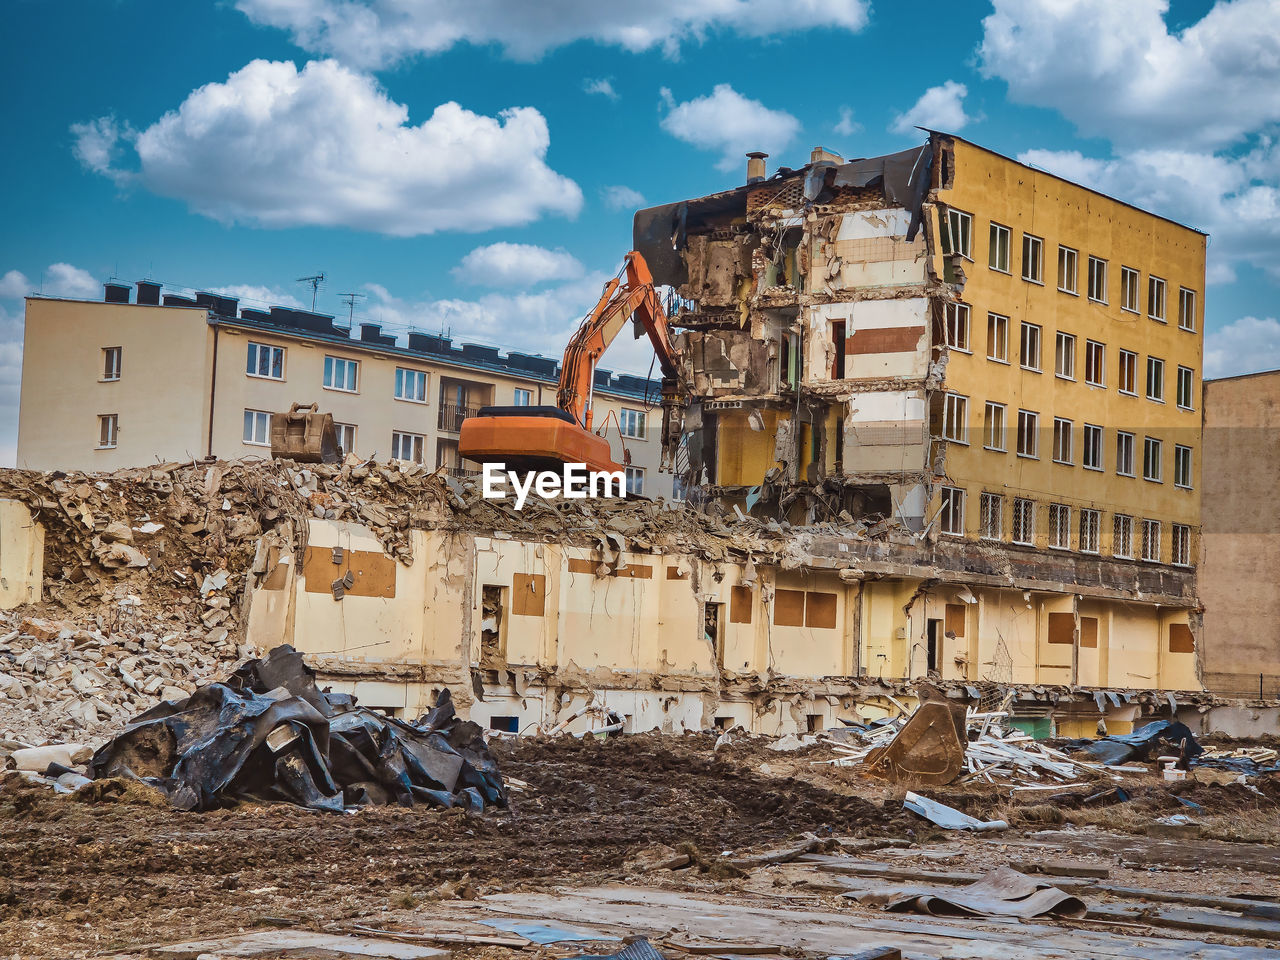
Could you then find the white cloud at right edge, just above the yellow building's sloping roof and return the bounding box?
[1018,143,1280,283]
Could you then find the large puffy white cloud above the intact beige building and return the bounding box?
[77,60,582,237]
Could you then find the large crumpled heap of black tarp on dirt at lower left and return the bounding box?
[90,644,507,812]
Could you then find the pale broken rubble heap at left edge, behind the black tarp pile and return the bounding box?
[0,604,253,746]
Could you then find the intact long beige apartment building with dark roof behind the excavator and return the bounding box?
[18,282,672,497]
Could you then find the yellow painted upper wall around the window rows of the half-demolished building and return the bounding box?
[936,140,1204,563]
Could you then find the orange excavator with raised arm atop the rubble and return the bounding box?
[458,251,686,471]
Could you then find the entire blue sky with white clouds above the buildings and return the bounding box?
[0,0,1280,463]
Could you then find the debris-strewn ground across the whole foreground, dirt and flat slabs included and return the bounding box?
[0,733,1280,960]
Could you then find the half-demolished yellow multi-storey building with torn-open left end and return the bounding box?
[634,132,1206,690]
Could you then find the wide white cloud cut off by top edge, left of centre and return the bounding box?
[236,0,868,68]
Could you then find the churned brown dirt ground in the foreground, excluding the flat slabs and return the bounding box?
[0,735,1280,957]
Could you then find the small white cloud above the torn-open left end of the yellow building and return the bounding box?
[662,83,800,172]
